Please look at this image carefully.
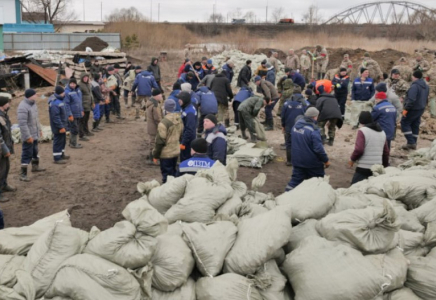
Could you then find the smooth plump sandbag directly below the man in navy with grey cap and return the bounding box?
[276,177,336,222]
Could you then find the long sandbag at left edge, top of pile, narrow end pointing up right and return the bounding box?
[0,210,71,255]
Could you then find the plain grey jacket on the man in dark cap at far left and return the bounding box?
[17,98,41,142]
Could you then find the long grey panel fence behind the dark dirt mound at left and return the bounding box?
[3,33,121,51]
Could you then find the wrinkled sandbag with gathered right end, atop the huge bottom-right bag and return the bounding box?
[316,200,400,254]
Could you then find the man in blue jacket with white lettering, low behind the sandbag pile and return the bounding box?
[179,139,215,176]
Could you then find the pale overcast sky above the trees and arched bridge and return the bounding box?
[72,0,436,22]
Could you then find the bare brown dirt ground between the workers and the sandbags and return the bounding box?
[1,49,436,230]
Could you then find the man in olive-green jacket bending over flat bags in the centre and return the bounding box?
[238,96,271,143]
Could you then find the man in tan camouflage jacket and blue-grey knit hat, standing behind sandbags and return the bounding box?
[153,99,183,183]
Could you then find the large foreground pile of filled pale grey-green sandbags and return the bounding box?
[0,141,436,300]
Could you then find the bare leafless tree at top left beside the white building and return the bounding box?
[20,0,76,24]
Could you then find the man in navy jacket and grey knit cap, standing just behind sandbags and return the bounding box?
[286,107,330,192]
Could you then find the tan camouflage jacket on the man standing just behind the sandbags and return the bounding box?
[153,113,183,158]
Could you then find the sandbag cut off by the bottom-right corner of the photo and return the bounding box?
[405,257,436,300]
